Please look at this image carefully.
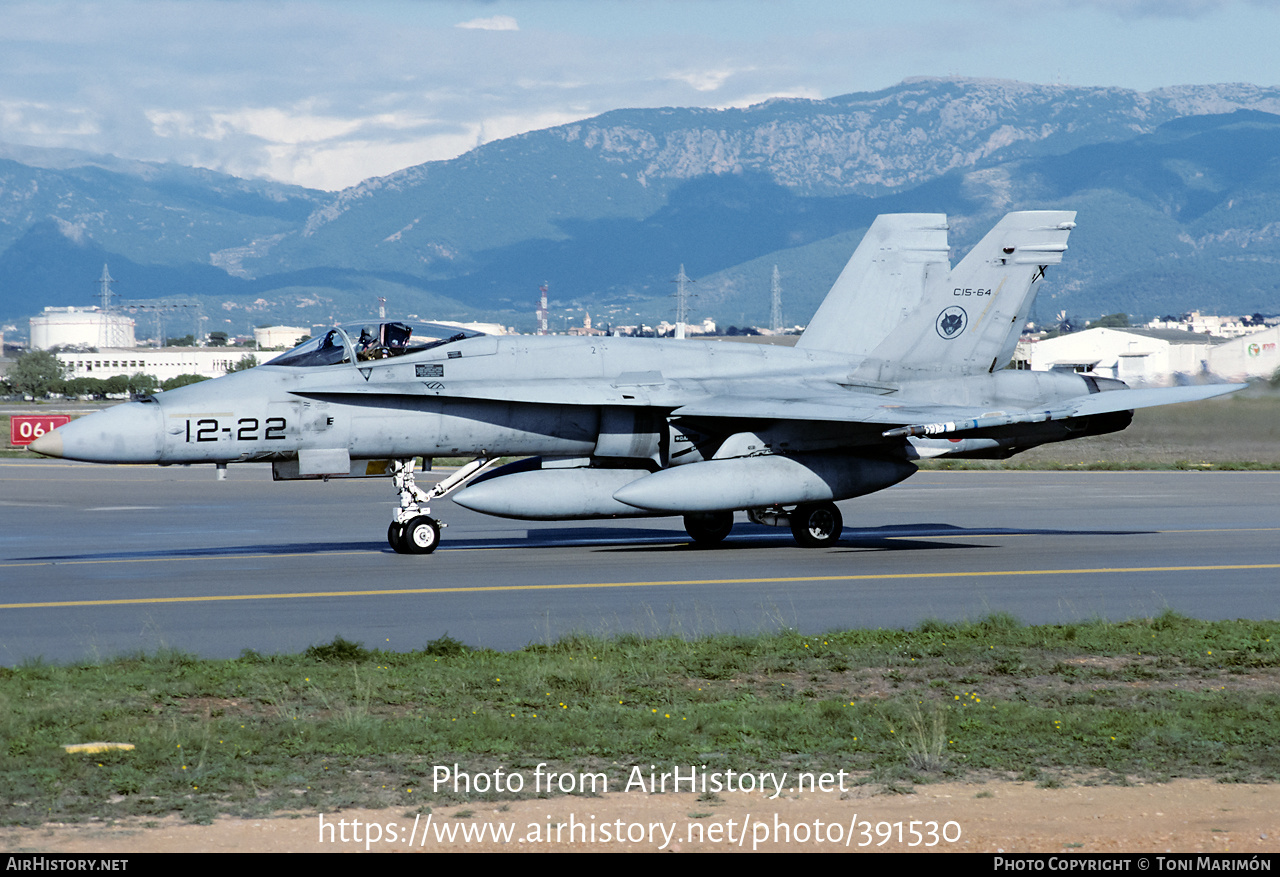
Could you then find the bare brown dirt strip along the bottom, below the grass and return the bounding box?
[0,780,1280,853]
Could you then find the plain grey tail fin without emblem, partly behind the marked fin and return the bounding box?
[796,214,951,357]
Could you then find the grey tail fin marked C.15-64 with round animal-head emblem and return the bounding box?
[856,210,1075,380]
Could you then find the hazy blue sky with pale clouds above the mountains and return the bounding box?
[0,0,1280,189]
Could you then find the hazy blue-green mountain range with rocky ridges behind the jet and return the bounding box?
[0,78,1280,334]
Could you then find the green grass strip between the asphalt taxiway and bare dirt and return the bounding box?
[0,612,1280,825]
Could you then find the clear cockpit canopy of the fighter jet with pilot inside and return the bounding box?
[268,320,484,369]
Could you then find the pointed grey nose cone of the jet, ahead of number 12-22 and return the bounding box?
[27,402,163,463]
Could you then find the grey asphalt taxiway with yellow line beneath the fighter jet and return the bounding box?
[0,460,1280,664]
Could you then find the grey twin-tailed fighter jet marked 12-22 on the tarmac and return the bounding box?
[31,210,1239,554]
